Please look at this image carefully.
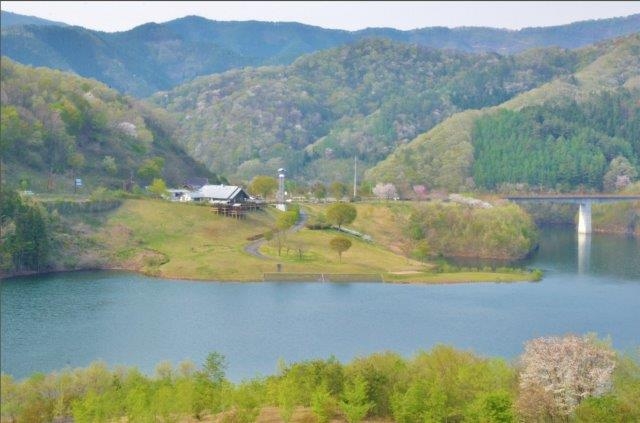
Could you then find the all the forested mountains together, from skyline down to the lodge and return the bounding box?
[2,10,640,194]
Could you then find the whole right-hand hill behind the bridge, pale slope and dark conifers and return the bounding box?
[367,34,640,192]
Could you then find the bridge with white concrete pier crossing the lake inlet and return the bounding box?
[505,194,640,234]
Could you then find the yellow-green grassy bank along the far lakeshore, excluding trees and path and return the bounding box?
[96,200,535,283]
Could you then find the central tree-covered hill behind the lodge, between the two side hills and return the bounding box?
[152,40,584,182]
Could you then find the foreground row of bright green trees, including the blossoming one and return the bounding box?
[1,335,640,423]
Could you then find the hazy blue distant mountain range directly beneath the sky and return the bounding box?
[0,11,640,97]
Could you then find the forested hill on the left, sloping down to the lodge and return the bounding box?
[0,57,217,192]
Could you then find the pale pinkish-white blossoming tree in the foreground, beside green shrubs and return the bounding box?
[520,335,615,416]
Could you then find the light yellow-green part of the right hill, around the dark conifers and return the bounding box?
[366,34,640,192]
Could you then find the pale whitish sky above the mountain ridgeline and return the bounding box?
[2,1,640,32]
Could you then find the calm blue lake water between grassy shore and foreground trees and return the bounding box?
[0,229,640,381]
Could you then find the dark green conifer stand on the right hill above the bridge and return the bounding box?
[473,89,640,190]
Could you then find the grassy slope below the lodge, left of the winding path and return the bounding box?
[99,200,273,281]
